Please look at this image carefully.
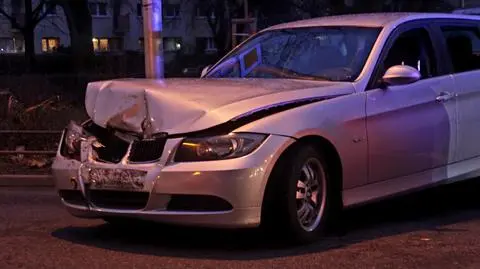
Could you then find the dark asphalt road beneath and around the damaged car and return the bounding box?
[0,180,480,269]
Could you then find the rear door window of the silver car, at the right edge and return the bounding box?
[441,26,480,73]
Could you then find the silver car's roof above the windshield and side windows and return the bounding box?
[268,12,480,30]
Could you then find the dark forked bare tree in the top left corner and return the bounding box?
[0,0,55,71]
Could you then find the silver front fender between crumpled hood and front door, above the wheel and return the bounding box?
[236,86,368,188]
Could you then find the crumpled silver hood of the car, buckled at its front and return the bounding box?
[85,79,354,134]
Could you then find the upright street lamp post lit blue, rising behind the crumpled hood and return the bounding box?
[142,0,164,79]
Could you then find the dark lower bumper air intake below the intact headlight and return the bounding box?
[167,195,233,212]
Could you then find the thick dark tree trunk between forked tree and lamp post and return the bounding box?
[59,0,93,71]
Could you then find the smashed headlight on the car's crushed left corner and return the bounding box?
[61,121,88,160]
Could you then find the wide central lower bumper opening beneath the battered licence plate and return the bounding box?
[88,190,149,210]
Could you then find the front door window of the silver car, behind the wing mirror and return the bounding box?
[380,28,438,79]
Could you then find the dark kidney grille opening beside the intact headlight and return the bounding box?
[129,136,166,163]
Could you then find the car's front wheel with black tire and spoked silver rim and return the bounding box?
[262,144,340,244]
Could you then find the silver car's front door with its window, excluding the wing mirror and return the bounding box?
[366,22,457,183]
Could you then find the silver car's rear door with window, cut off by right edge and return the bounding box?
[438,21,480,161]
